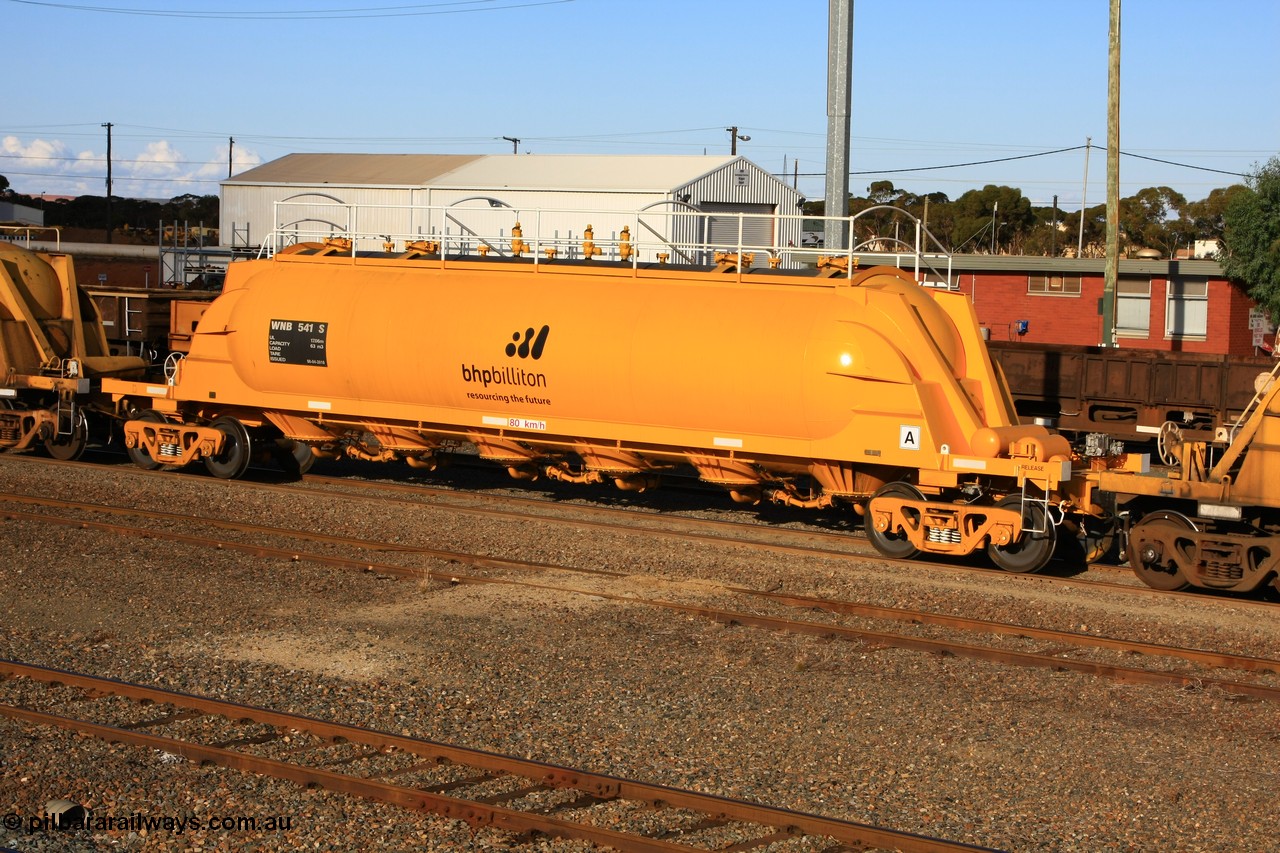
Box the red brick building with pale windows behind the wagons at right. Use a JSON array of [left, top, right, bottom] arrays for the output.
[[936, 255, 1275, 356]]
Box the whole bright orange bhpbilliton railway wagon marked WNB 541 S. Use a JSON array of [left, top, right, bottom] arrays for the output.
[[108, 202, 1083, 571]]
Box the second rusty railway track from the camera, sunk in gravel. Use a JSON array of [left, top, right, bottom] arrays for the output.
[[0, 481, 1280, 701]]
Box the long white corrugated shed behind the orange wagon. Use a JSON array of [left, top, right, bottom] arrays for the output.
[[221, 154, 804, 263]]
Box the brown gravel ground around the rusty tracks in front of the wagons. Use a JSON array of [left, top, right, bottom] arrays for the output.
[[0, 456, 1280, 852]]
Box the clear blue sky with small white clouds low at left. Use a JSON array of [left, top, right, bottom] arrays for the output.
[[0, 0, 1280, 210]]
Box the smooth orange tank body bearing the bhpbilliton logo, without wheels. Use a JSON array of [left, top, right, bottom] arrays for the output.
[[162, 254, 1016, 479]]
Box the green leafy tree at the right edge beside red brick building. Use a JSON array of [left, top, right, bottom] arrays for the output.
[[1219, 158, 1280, 321]]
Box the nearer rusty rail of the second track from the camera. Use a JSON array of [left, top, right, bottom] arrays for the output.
[[6, 510, 1280, 702]]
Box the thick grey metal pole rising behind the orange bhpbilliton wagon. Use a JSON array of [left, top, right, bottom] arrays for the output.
[[823, 0, 854, 250]]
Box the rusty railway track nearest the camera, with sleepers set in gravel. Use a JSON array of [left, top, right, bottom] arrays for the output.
[[0, 661, 989, 853]]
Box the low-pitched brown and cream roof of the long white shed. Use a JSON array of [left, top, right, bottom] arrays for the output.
[[223, 154, 742, 192]]
